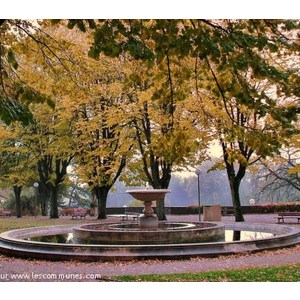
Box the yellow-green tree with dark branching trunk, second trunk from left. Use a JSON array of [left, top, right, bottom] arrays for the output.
[[18, 103, 75, 218]]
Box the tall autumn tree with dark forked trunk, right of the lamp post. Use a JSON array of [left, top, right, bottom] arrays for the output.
[[197, 23, 299, 221]]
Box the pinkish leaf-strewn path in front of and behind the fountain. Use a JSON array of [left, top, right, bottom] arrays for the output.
[[0, 215, 300, 281]]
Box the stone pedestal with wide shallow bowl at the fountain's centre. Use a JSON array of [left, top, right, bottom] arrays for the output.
[[125, 189, 170, 229]]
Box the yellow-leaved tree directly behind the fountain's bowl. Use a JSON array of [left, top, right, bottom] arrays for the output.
[[122, 60, 208, 220]]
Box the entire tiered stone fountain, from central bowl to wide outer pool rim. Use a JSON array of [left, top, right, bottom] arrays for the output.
[[0, 190, 300, 261]]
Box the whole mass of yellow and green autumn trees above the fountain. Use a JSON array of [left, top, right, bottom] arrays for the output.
[[0, 20, 300, 221]]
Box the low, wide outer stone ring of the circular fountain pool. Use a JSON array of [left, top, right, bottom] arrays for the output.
[[0, 222, 300, 261]]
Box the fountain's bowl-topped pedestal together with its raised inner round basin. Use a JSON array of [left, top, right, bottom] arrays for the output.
[[73, 189, 225, 245]]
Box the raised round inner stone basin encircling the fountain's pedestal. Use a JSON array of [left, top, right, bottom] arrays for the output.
[[73, 222, 225, 245]]
